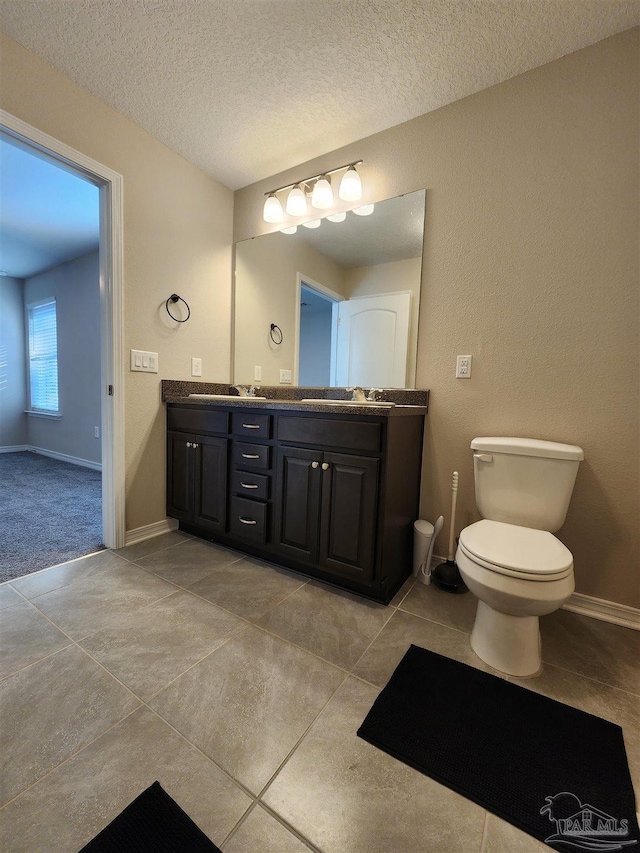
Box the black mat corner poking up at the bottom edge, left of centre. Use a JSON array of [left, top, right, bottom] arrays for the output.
[[80, 782, 221, 853]]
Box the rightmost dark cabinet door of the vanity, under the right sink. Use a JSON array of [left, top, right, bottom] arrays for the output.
[[318, 453, 380, 581]]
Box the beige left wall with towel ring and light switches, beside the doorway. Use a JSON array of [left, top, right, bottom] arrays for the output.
[[0, 34, 233, 530]]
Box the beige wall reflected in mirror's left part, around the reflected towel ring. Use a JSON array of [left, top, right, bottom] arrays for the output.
[[233, 234, 344, 385]]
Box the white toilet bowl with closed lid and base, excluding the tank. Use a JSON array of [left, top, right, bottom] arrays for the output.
[[456, 520, 574, 677]]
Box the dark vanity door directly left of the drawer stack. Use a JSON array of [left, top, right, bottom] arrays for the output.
[[193, 436, 228, 533]]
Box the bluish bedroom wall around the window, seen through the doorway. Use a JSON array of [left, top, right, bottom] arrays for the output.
[[24, 251, 101, 463]]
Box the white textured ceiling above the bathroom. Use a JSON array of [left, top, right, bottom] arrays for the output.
[[0, 0, 640, 189]]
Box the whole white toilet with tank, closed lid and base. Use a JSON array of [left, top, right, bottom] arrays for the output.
[[456, 438, 584, 677]]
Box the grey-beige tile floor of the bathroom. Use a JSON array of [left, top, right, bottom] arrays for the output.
[[0, 533, 640, 853]]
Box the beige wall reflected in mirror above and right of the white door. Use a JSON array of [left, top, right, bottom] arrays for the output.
[[344, 258, 422, 388]]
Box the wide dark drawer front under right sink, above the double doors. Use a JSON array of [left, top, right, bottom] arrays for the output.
[[278, 417, 382, 453]]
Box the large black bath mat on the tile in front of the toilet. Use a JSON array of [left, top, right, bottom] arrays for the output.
[[358, 646, 640, 853]]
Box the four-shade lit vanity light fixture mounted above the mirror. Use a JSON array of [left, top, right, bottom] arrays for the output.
[[262, 160, 362, 223]]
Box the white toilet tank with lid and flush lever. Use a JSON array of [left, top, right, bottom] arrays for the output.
[[471, 438, 584, 533]]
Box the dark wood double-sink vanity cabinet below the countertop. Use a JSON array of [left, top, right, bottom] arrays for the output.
[[167, 403, 424, 602]]
